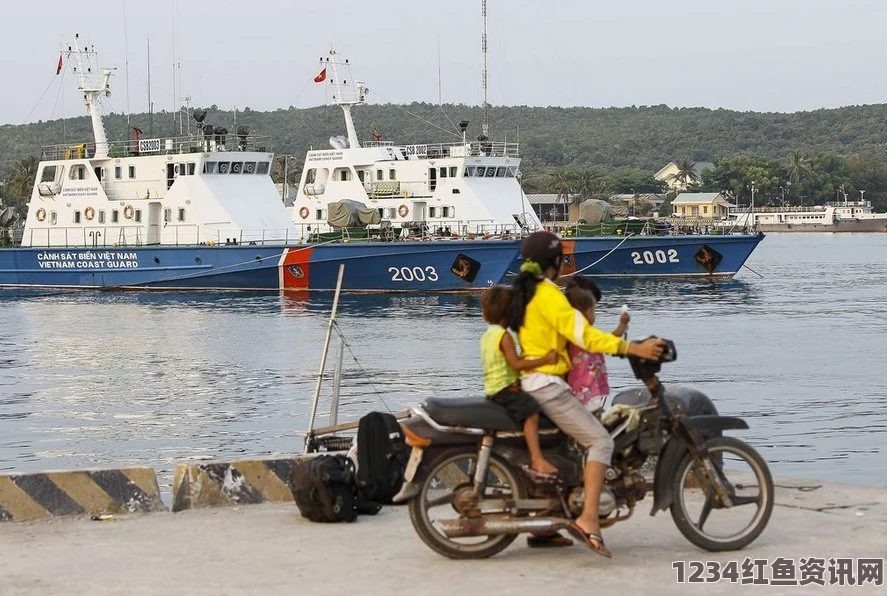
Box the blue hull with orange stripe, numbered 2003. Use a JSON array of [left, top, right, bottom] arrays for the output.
[[0, 241, 519, 292]]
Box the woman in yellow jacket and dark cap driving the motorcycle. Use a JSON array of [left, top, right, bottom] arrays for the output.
[[510, 232, 663, 557]]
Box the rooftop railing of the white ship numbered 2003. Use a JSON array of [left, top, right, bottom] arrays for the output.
[[40, 133, 271, 160]]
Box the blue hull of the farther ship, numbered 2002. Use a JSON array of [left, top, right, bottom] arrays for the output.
[[511, 234, 764, 279]]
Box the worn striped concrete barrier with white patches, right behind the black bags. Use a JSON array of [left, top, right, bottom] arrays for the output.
[[172, 455, 310, 511]]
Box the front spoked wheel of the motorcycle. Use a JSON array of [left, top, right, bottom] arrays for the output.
[[671, 437, 774, 551]]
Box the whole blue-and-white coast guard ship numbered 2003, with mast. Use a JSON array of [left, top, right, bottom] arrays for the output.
[[0, 38, 519, 291]]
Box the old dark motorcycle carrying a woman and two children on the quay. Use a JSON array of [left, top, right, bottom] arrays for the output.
[[394, 340, 774, 559]]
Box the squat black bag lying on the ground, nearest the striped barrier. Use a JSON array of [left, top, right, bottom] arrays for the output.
[[290, 455, 381, 522]]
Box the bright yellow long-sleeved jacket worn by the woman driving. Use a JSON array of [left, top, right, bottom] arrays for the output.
[[518, 279, 628, 376]]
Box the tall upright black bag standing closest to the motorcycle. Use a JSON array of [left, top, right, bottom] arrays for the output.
[[357, 412, 409, 503]]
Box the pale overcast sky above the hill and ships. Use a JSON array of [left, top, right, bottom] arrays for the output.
[[0, 0, 887, 123]]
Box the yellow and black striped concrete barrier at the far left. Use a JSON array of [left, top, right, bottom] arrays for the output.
[[0, 468, 167, 521]]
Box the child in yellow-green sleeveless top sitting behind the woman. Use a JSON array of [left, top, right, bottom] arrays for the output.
[[480, 286, 557, 475]]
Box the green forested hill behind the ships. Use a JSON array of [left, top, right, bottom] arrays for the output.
[[0, 103, 887, 196]]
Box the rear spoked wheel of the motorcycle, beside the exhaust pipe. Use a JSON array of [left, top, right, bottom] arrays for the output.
[[410, 449, 520, 559]]
